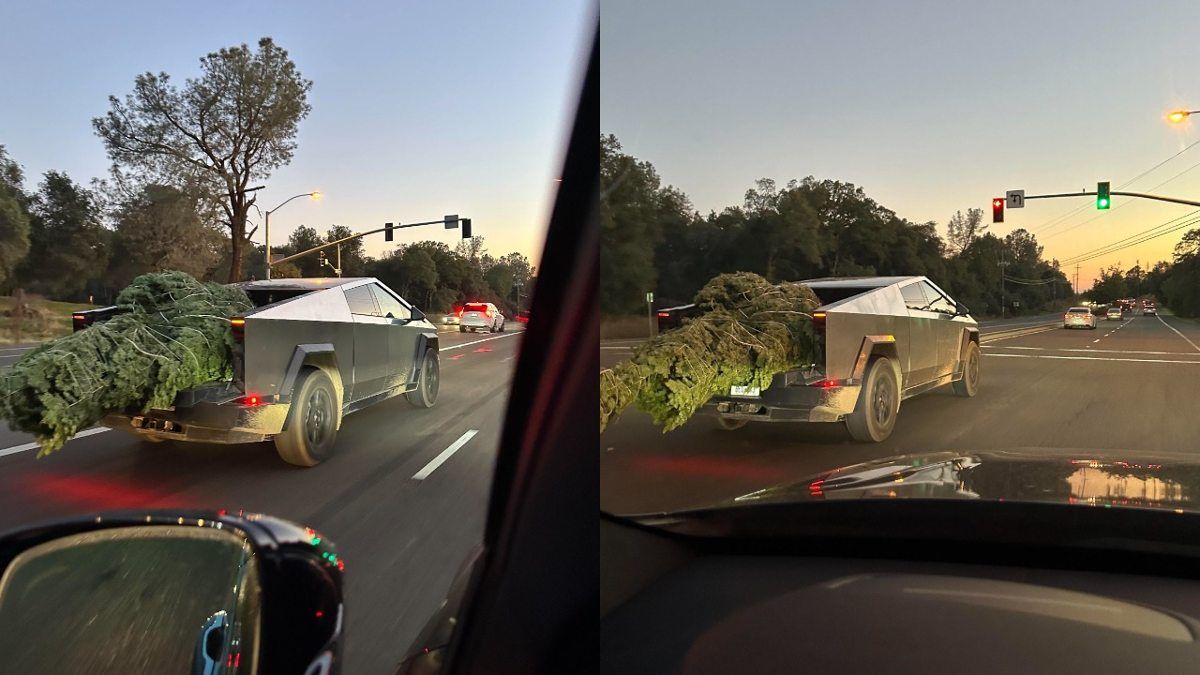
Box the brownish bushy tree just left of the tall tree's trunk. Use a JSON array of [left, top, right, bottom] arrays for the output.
[[106, 185, 226, 288]]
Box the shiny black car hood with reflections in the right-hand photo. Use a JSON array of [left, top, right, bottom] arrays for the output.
[[725, 448, 1200, 513]]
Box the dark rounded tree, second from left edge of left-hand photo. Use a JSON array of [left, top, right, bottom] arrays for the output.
[[18, 171, 109, 300]]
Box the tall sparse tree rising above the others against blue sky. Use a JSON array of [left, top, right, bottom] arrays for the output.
[[92, 37, 312, 281]]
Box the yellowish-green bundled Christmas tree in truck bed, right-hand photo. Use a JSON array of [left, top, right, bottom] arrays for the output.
[[600, 273, 820, 431]]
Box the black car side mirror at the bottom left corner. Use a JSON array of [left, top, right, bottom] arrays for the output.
[[0, 513, 344, 674]]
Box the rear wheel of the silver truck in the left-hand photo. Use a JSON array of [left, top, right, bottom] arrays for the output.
[[275, 368, 337, 466]]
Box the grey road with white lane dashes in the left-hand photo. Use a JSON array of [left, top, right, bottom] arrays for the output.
[[0, 322, 522, 674]]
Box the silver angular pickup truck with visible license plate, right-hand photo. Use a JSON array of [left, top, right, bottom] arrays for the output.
[[706, 276, 982, 442]]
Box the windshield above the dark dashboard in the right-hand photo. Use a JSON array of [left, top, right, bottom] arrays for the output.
[[599, 0, 1200, 522]]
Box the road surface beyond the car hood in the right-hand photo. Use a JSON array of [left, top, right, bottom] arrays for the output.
[[600, 313, 1200, 514]]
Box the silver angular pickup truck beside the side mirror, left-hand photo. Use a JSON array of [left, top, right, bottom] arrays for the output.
[[78, 277, 440, 466]]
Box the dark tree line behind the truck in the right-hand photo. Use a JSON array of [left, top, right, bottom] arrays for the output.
[[600, 135, 1072, 316]]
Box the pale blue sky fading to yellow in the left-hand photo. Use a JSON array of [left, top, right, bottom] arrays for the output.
[[0, 0, 595, 264]]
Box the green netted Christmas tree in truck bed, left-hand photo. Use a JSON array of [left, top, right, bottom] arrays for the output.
[[0, 271, 252, 455]]
